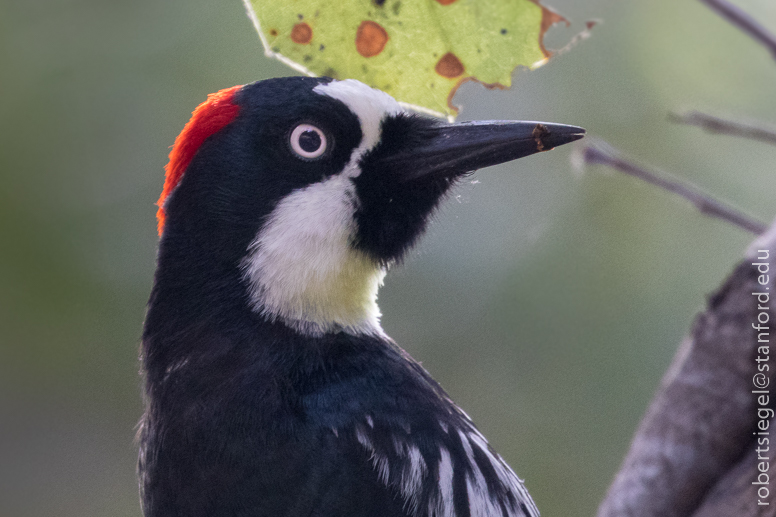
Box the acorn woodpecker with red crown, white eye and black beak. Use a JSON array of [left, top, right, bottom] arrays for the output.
[[139, 77, 584, 517]]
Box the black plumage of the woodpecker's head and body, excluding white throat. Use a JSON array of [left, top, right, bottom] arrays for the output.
[[139, 78, 581, 517]]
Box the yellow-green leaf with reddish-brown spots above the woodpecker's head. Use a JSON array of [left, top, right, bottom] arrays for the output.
[[244, 0, 565, 117]]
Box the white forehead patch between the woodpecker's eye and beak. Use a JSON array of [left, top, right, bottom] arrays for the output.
[[313, 79, 404, 158]]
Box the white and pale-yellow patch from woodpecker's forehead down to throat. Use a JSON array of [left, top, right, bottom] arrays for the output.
[[242, 80, 402, 336]]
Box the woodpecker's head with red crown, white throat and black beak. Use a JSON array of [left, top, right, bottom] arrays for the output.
[[157, 77, 584, 335]]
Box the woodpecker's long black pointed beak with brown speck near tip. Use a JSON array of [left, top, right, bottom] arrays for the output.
[[380, 120, 585, 181]]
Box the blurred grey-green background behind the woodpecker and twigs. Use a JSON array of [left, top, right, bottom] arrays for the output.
[[0, 0, 776, 517]]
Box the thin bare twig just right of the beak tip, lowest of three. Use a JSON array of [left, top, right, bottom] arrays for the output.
[[582, 141, 768, 235]]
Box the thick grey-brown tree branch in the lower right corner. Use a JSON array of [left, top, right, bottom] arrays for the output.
[[598, 225, 776, 517]]
